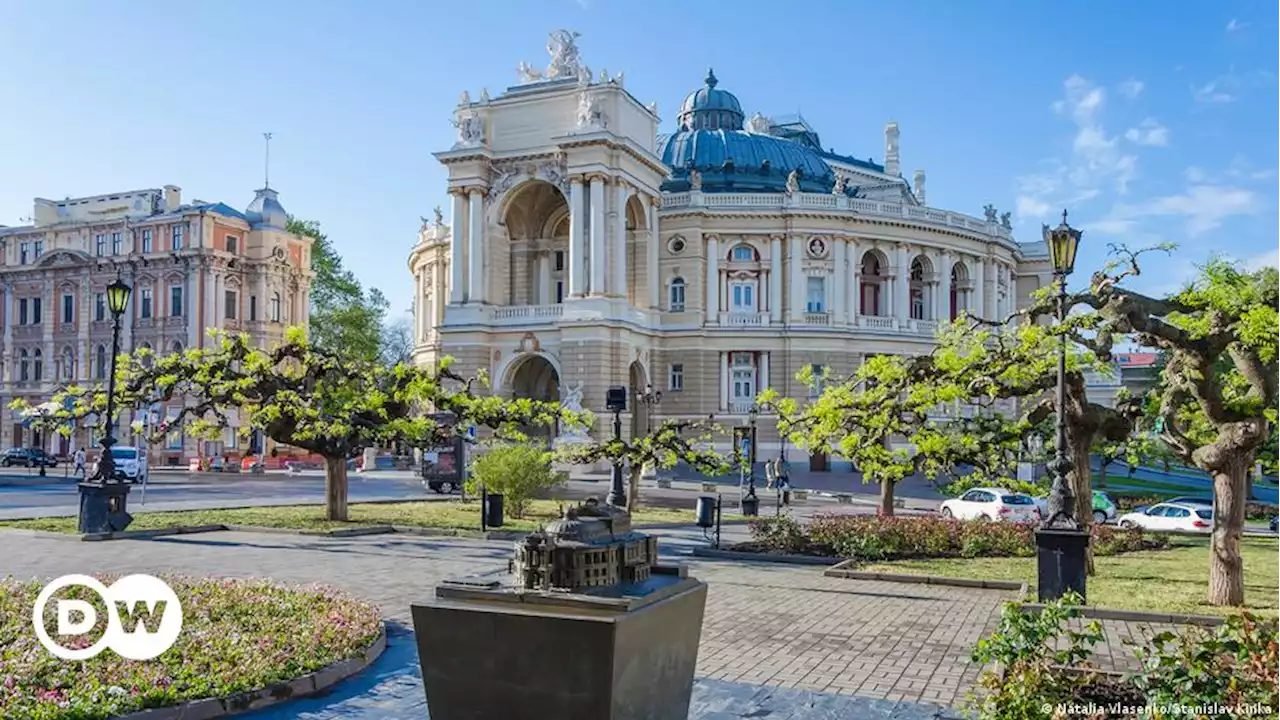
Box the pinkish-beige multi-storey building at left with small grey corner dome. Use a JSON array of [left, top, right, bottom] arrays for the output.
[[0, 186, 311, 464]]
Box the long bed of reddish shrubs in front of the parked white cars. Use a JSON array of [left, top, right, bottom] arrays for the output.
[[733, 515, 1169, 561]]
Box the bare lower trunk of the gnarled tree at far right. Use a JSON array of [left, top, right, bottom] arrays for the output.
[[1208, 459, 1249, 606]]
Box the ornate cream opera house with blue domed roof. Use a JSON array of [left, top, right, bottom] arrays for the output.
[[408, 31, 1052, 450]]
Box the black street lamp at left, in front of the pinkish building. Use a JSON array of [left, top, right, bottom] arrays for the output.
[[79, 277, 133, 533]]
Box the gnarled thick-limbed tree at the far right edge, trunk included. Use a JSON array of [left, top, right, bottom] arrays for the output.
[[1080, 254, 1280, 605]]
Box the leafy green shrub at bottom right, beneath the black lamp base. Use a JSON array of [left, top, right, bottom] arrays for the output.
[[973, 594, 1103, 720]]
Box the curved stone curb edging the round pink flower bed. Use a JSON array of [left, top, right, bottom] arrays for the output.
[[114, 621, 387, 720]]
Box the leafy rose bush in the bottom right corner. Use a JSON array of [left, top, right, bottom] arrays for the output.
[[1134, 614, 1280, 717]]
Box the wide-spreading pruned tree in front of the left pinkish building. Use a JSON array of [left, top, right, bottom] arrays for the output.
[[13, 328, 581, 520]]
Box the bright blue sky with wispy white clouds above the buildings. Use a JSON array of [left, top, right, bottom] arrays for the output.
[[0, 0, 1280, 310]]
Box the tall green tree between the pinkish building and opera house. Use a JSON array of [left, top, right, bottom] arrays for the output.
[[285, 218, 388, 361]]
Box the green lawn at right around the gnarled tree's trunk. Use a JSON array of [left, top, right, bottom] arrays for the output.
[[858, 537, 1280, 616]]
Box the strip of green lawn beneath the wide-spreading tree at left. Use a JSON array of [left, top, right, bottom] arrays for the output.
[[0, 500, 694, 533]]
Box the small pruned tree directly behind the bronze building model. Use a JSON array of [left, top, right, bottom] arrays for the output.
[[556, 420, 731, 512]]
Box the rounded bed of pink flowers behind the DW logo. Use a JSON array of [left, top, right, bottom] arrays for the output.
[[0, 577, 381, 720]]
